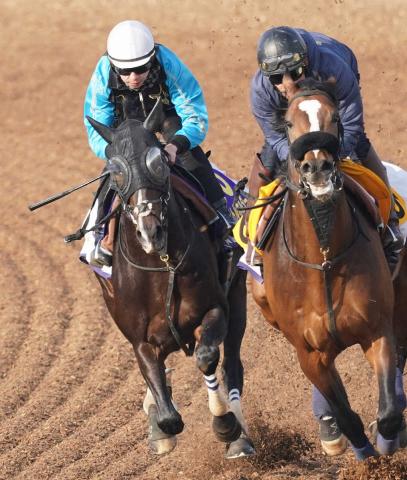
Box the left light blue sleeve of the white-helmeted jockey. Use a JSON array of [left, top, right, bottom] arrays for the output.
[[83, 56, 114, 160]]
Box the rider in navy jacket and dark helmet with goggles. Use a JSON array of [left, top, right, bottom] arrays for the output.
[[249, 26, 404, 270]]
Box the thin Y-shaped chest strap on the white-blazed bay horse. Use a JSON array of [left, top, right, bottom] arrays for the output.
[[283, 190, 361, 350]]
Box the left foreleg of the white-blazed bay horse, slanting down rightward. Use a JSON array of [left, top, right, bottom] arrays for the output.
[[297, 347, 375, 460]]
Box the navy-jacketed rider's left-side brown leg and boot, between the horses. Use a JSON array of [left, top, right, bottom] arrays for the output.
[[244, 153, 273, 266]]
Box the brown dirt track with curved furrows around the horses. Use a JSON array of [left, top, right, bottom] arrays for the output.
[[0, 0, 407, 480]]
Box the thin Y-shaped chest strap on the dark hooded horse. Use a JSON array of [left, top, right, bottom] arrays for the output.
[[117, 189, 195, 357]]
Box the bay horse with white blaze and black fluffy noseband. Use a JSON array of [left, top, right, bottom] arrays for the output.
[[253, 74, 402, 460]]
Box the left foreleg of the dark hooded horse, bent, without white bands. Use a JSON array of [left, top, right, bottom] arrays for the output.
[[133, 342, 184, 435]]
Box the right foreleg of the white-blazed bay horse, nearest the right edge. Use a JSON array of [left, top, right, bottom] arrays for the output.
[[364, 337, 403, 455]]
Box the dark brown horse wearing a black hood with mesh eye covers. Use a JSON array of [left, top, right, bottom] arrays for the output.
[[89, 107, 254, 458]]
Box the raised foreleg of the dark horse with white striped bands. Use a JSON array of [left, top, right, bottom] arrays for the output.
[[195, 307, 241, 442]]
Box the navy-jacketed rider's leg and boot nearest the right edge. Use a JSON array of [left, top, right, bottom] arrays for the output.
[[363, 145, 404, 273]]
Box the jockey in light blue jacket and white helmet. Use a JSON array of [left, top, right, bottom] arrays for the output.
[[84, 20, 233, 266]]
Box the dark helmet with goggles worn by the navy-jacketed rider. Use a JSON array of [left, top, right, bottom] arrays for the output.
[[257, 27, 307, 76]]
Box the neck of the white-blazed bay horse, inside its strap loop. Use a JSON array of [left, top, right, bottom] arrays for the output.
[[284, 191, 355, 262]]
